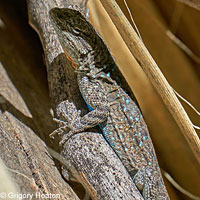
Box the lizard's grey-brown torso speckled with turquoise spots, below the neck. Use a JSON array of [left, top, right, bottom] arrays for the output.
[[78, 71, 169, 200]]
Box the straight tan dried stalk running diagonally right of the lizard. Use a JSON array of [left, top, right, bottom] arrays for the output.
[[101, 0, 200, 163]]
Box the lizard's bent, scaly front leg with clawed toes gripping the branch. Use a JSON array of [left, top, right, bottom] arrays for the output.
[[52, 73, 109, 145]]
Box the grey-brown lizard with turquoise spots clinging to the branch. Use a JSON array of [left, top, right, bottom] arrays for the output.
[[49, 8, 169, 200]]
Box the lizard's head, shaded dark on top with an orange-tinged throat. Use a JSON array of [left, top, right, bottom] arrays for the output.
[[49, 8, 95, 66]]
